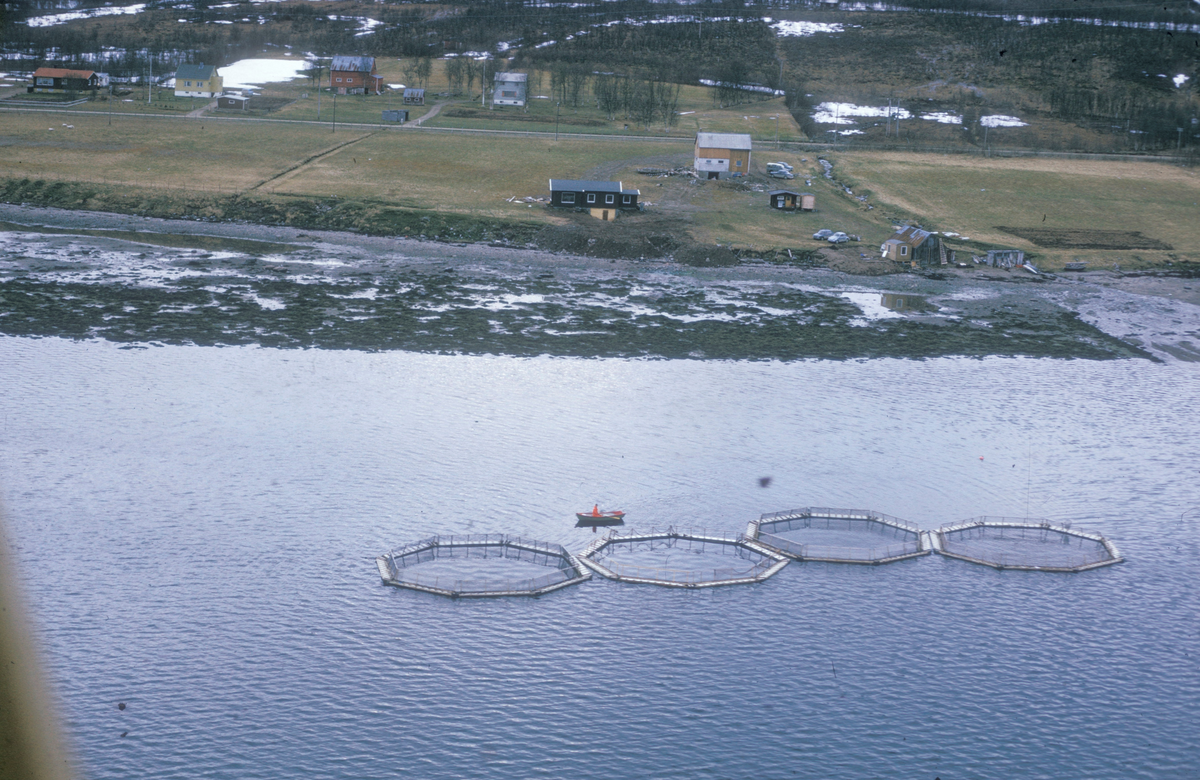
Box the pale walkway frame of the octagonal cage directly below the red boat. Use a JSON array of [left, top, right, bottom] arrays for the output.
[[578, 526, 788, 588]]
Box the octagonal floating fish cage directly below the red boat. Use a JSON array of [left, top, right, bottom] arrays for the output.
[[580, 527, 787, 588]]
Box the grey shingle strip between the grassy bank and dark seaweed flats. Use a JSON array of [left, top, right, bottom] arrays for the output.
[[0, 204, 1200, 362]]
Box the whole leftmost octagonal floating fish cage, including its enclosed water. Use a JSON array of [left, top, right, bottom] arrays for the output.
[[377, 534, 589, 596]]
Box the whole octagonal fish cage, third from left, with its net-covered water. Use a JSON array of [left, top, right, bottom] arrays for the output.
[[746, 506, 930, 564]]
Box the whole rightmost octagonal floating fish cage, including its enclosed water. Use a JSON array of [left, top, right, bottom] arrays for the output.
[[934, 517, 1123, 571]]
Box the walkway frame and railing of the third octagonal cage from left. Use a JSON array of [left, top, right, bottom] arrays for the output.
[[745, 506, 931, 565]]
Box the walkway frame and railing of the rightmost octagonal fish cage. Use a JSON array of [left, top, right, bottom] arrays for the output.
[[931, 516, 1124, 571]]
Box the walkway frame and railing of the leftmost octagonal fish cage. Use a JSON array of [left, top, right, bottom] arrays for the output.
[[376, 534, 592, 598]]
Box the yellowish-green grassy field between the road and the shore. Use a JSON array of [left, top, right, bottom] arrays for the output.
[[0, 106, 1200, 270]]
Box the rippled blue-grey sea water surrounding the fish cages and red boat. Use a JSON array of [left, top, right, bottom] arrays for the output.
[[0, 337, 1200, 780]]
